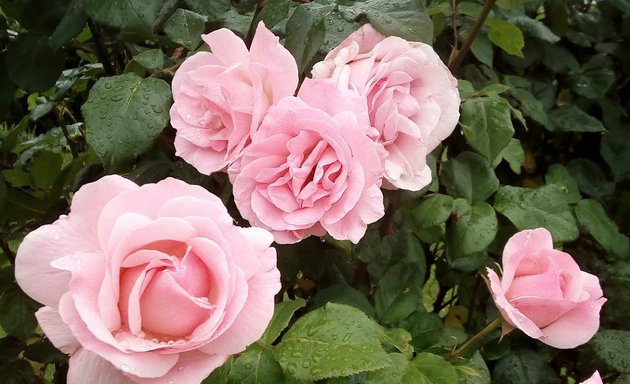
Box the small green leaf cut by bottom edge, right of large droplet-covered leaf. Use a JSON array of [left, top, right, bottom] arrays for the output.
[[400, 352, 459, 384]]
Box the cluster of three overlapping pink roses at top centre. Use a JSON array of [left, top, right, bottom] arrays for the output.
[[171, 22, 460, 244]]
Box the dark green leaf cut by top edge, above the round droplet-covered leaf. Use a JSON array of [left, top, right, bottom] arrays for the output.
[[84, 0, 164, 37]]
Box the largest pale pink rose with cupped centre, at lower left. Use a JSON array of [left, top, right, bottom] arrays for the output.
[[15, 176, 280, 384]]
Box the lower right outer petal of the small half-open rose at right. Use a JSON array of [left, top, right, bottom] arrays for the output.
[[540, 298, 606, 349]]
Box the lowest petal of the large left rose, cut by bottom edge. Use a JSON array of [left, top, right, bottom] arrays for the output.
[[67, 349, 133, 384]]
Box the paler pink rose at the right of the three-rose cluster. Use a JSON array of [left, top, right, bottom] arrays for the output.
[[312, 24, 460, 191]]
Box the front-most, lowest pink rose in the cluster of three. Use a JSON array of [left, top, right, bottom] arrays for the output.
[[228, 79, 384, 244]]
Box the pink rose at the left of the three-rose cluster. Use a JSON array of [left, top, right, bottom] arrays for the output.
[[170, 22, 298, 174]]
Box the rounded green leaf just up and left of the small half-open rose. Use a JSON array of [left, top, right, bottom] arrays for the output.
[[446, 199, 498, 258]]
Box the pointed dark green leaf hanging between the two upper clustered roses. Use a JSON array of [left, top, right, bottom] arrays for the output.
[[284, 3, 333, 73]]
